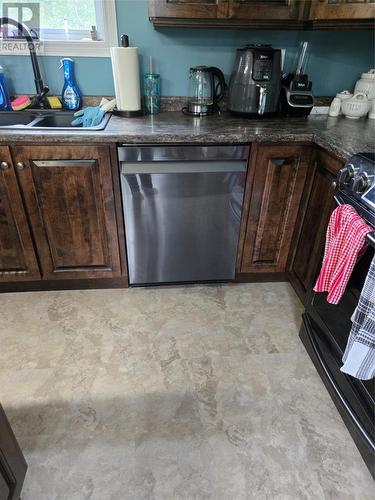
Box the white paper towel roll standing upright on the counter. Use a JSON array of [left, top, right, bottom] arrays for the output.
[[111, 47, 141, 111]]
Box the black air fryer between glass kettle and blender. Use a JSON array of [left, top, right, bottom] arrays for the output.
[[228, 45, 281, 116]]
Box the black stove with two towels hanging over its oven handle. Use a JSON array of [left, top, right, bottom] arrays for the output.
[[300, 153, 375, 477]]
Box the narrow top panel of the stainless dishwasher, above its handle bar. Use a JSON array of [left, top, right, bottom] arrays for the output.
[[117, 144, 250, 162]]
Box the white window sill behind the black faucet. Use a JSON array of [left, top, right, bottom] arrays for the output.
[[0, 40, 110, 57]]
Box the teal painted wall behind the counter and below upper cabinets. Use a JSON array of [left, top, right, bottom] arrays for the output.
[[0, 0, 375, 95]]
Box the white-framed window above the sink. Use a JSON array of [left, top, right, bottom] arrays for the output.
[[0, 0, 117, 56]]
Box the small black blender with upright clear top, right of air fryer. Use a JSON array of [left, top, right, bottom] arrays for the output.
[[280, 42, 314, 117]]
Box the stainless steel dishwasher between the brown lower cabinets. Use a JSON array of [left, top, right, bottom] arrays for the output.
[[118, 145, 249, 285]]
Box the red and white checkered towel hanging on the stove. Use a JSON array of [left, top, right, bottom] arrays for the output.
[[314, 205, 372, 304]]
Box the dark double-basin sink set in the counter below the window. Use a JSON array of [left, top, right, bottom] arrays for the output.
[[0, 109, 111, 130]]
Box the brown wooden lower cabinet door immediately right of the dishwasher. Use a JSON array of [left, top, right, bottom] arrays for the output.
[[239, 145, 311, 273]]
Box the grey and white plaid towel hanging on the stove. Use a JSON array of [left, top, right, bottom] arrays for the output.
[[341, 256, 375, 380]]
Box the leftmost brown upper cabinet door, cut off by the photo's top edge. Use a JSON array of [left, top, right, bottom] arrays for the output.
[[149, 0, 228, 19]]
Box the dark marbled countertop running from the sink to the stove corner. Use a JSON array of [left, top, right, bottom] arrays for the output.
[[0, 111, 375, 160]]
